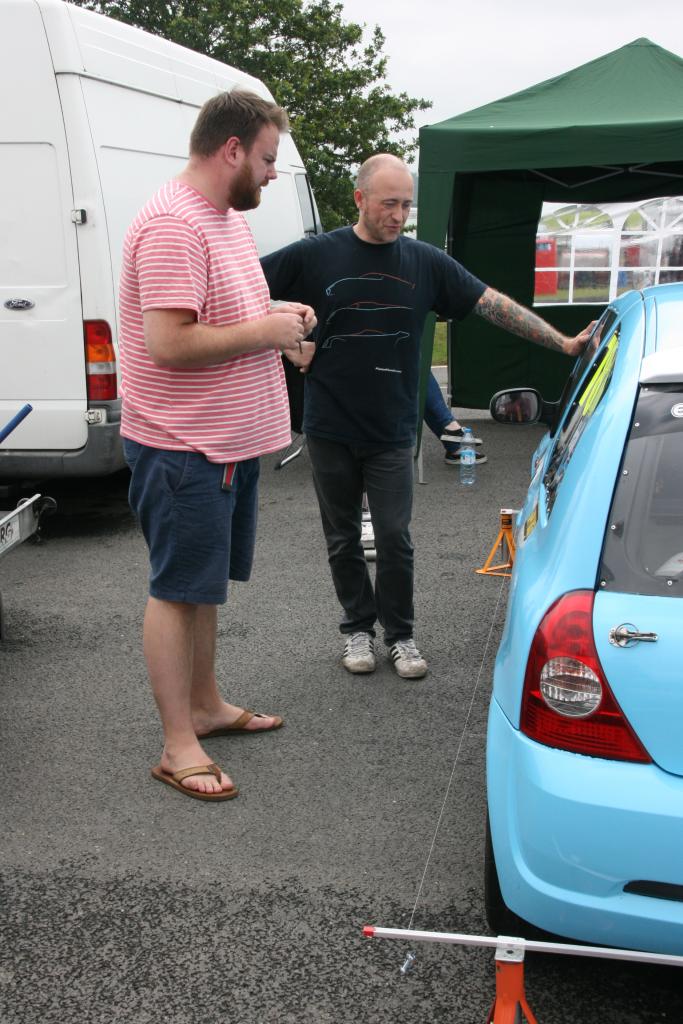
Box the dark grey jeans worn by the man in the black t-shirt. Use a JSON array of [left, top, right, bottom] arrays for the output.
[[306, 436, 415, 646]]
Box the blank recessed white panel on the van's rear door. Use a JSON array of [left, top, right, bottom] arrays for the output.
[[0, 142, 68, 289]]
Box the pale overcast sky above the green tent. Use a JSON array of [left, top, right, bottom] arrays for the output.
[[341, 0, 683, 127]]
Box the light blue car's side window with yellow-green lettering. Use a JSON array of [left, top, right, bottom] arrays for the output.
[[543, 321, 618, 515]]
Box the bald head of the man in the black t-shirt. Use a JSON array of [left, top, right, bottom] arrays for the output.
[[353, 153, 413, 245]]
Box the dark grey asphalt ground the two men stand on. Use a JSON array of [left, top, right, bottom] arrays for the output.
[[0, 382, 683, 1024]]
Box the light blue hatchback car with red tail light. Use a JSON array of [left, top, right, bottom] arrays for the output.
[[485, 285, 683, 954]]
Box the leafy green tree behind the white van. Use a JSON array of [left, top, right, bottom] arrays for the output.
[[72, 0, 431, 230]]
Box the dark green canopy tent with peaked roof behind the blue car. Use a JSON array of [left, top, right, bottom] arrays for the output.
[[418, 39, 683, 409]]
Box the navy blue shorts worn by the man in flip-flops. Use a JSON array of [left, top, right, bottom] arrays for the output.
[[123, 438, 259, 604]]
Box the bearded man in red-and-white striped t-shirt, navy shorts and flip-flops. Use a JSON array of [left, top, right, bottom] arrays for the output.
[[120, 90, 315, 801]]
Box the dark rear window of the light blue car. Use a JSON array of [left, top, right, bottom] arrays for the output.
[[598, 383, 683, 597]]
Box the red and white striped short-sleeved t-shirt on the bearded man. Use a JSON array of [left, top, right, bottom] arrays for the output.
[[120, 180, 291, 463]]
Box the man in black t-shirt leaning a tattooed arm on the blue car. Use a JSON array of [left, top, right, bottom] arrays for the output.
[[261, 154, 588, 679]]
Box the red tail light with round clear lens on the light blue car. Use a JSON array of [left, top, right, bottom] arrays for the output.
[[520, 590, 651, 763]]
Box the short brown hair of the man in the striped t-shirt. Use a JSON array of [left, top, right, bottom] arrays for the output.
[[189, 89, 289, 157]]
